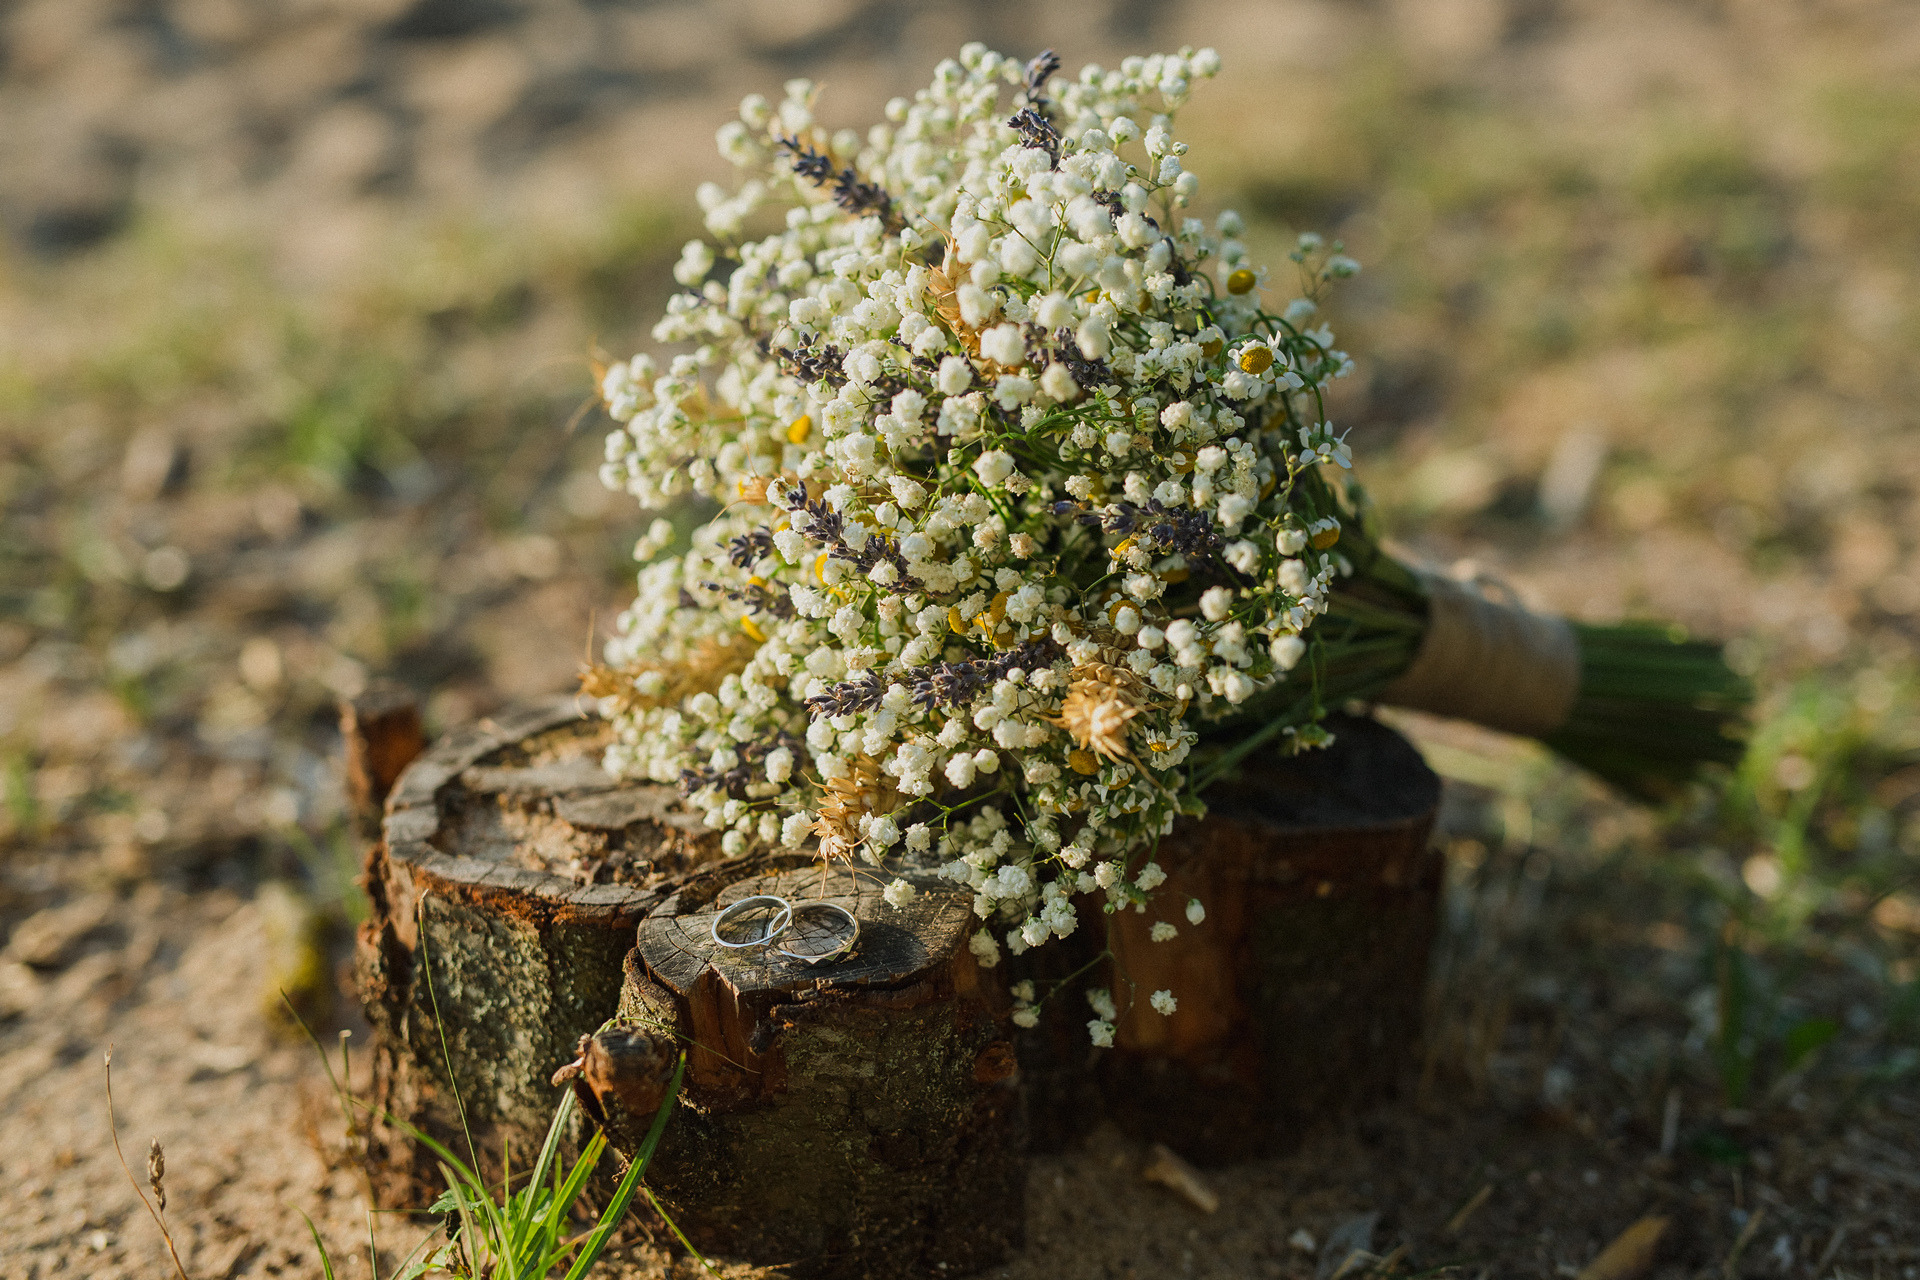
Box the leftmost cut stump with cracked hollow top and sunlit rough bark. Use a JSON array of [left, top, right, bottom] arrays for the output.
[[349, 699, 718, 1203]]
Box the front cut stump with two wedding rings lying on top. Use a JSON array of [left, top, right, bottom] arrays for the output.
[[582, 864, 1025, 1280]]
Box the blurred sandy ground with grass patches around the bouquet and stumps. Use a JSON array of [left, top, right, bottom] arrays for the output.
[[0, 0, 1920, 1276]]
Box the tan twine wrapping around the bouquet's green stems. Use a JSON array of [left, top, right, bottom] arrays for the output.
[[1380, 574, 1580, 737]]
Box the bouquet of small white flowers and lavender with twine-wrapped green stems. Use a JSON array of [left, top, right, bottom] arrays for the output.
[[584, 44, 1745, 963]]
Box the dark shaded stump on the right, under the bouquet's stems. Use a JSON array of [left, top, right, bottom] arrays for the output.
[[1021, 718, 1444, 1165]]
